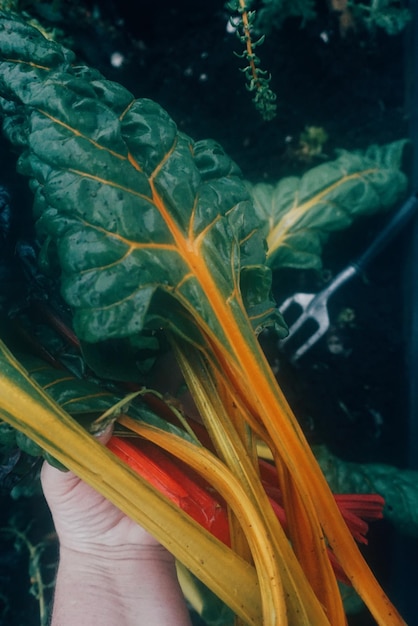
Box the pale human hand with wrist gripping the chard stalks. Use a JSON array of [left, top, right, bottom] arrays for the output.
[[41, 432, 190, 626]]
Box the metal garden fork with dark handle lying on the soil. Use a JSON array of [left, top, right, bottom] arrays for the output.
[[278, 193, 418, 363]]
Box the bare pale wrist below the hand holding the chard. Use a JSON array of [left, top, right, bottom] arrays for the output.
[[52, 545, 190, 626]]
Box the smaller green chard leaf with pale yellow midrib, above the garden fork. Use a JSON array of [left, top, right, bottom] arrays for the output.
[[248, 141, 407, 269]]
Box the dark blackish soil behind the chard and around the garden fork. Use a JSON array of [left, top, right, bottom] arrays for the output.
[[0, 0, 416, 626]]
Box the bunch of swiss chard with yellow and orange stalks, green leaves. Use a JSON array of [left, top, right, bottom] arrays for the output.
[[0, 14, 406, 626]]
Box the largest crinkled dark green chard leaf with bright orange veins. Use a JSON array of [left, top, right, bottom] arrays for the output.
[[0, 13, 284, 342]]
